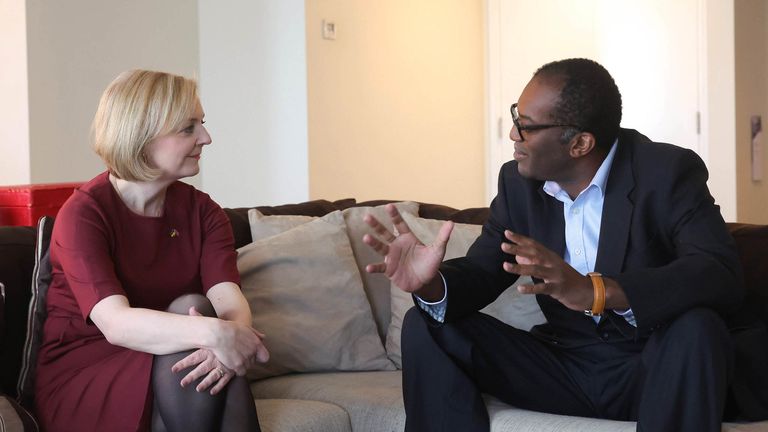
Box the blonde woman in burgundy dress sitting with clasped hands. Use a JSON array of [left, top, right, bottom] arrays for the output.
[[35, 70, 269, 432]]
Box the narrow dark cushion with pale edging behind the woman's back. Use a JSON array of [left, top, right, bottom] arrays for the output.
[[17, 216, 54, 410]]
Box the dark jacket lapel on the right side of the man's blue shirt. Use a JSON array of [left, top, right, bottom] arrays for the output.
[[595, 129, 635, 274]]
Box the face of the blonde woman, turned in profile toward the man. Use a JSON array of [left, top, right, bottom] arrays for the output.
[[146, 103, 211, 180]]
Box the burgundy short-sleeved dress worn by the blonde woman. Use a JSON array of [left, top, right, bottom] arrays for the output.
[[35, 173, 240, 432]]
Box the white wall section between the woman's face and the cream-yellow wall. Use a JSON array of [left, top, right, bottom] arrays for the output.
[[200, 0, 309, 207]]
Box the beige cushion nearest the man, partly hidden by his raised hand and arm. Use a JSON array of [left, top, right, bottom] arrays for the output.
[[385, 215, 546, 368]]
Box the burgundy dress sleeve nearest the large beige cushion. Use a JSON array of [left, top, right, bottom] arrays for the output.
[[200, 195, 240, 293]]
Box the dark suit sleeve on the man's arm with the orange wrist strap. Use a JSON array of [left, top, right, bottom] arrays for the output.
[[603, 150, 744, 331]]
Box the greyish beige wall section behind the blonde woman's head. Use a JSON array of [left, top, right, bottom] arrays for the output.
[[22, 0, 198, 184]]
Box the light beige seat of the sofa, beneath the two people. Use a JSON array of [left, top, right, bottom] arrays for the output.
[[251, 371, 768, 432]]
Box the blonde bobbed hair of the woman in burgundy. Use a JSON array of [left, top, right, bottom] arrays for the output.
[[91, 70, 199, 181]]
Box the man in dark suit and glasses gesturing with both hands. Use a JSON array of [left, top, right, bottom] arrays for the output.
[[364, 59, 743, 432]]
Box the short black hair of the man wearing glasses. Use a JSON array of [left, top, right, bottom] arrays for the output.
[[533, 58, 621, 151]]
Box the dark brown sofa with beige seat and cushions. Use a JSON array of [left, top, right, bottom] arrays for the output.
[[0, 199, 768, 432]]
